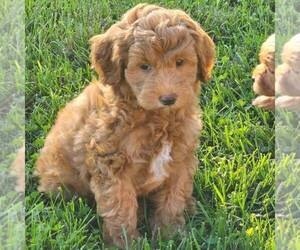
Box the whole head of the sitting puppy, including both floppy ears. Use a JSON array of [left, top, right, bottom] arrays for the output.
[[91, 4, 215, 110]]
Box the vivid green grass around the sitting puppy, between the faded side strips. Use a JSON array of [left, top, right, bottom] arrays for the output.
[[26, 0, 275, 250]]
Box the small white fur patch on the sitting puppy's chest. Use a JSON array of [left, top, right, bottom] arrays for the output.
[[150, 143, 172, 180]]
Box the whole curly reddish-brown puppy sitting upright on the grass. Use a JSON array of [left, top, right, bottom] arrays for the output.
[[36, 4, 215, 247]]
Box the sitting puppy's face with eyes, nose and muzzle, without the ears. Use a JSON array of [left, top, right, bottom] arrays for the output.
[[125, 23, 198, 109]]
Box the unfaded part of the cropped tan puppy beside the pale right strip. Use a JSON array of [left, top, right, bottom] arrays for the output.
[[252, 34, 275, 110]]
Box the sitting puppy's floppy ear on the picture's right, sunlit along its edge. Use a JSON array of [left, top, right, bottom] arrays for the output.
[[181, 13, 215, 82]]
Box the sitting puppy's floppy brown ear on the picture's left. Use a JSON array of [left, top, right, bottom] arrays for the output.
[[90, 27, 129, 85]]
